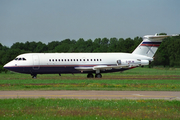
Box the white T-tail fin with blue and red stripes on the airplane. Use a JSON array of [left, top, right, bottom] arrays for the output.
[[132, 34, 178, 57]]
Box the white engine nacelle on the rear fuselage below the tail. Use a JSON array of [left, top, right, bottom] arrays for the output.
[[117, 59, 149, 67]]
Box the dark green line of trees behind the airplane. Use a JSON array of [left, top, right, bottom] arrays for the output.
[[0, 33, 180, 72]]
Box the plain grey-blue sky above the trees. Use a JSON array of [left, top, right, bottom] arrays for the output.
[[0, 0, 180, 47]]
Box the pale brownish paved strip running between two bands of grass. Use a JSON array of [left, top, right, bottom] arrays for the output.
[[0, 90, 180, 100]]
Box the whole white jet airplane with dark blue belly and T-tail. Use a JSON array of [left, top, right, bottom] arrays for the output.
[[4, 34, 179, 78]]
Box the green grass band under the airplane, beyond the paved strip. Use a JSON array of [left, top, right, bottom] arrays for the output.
[[0, 68, 180, 91]]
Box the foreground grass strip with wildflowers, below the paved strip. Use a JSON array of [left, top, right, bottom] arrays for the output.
[[0, 98, 180, 120]]
